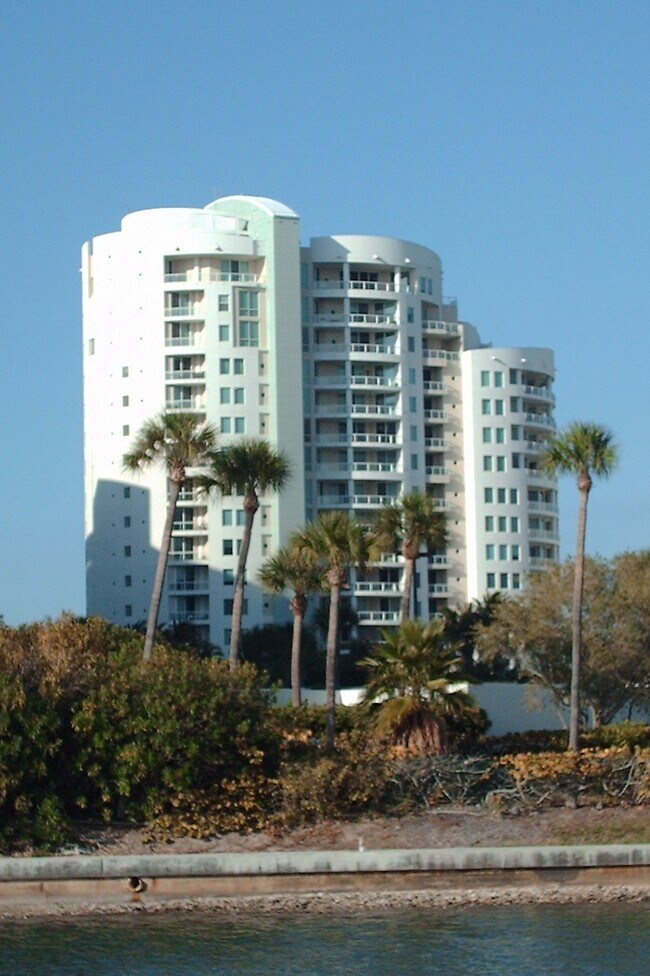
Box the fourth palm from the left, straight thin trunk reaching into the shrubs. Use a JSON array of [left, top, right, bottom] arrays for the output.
[[291, 511, 373, 750]]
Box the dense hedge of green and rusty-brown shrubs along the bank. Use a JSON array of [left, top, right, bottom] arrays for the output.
[[0, 616, 650, 851]]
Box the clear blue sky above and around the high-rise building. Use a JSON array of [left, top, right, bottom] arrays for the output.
[[0, 0, 650, 624]]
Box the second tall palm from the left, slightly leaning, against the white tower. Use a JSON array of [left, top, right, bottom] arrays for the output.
[[198, 437, 289, 670]]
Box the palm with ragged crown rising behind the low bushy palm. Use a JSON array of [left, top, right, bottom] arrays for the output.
[[374, 491, 447, 622]]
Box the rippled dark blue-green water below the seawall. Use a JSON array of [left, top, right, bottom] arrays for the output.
[[0, 904, 650, 976]]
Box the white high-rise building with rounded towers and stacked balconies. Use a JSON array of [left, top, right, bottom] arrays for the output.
[[82, 196, 558, 647]]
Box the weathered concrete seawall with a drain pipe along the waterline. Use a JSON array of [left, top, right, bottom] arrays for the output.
[[0, 844, 650, 916]]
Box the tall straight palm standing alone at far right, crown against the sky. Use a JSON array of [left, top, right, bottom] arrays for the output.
[[541, 422, 618, 751]]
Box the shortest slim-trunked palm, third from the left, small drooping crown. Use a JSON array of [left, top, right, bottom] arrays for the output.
[[257, 546, 323, 707]]
